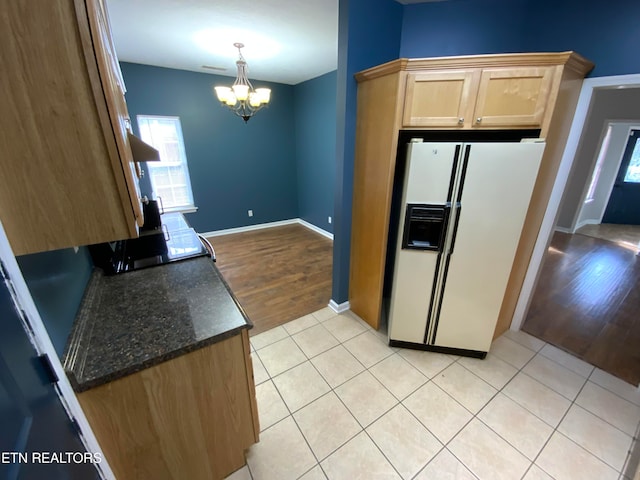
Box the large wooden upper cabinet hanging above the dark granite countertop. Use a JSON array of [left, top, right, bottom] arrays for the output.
[[0, 0, 143, 255]]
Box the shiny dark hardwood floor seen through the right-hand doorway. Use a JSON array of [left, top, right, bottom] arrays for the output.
[[522, 232, 640, 385]]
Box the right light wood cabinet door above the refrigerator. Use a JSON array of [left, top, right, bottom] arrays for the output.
[[473, 67, 555, 128]]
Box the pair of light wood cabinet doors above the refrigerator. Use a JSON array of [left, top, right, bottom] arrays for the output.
[[402, 67, 556, 129]]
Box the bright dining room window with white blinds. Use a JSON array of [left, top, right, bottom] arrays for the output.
[[137, 115, 195, 211]]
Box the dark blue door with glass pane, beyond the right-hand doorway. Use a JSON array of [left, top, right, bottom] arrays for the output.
[[602, 130, 640, 225]]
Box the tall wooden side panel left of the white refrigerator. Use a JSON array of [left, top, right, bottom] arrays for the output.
[[349, 73, 405, 329]]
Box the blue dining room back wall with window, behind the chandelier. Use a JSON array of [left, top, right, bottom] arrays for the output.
[[121, 63, 298, 232]]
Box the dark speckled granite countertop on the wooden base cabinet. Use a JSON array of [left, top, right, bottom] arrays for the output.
[[63, 257, 252, 392]]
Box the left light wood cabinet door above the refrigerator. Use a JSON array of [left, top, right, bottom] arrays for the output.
[[402, 70, 474, 127]]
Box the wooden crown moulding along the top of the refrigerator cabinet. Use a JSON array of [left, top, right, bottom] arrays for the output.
[[355, 51, 594, 82]]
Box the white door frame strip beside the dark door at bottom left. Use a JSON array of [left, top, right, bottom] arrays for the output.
[[0, 222, 115, 480]]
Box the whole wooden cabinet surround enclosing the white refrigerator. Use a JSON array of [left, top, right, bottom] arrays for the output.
[[349, 52, 593, 334]]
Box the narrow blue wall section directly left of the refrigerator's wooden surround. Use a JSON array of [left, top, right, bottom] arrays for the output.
[[331, 0, 403, 303]]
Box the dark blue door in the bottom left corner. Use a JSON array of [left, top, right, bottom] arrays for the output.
[[0, 263, 100, 480]]
